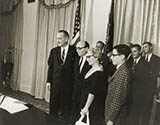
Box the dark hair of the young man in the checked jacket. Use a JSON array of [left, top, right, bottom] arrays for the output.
[[113, 44, 130, 58]]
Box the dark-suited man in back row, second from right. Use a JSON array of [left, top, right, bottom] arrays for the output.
[[128, 44, 152, 125]]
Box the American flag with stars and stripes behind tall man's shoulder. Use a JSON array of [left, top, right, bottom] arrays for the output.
[[72, 0, 81, 45]]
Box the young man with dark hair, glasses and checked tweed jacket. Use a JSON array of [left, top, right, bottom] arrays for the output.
[[105, 44, 130, 125]]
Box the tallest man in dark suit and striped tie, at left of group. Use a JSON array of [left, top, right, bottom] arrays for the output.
[[47, 30, 77, 125]]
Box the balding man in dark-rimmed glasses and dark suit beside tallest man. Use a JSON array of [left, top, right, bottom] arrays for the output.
[[72, 41, 91, 122]]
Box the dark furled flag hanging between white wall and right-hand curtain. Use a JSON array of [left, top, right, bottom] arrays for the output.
[[105, 0, 114, 53]]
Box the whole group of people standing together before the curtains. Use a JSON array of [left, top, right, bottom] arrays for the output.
[[47, 30, 160, 125]]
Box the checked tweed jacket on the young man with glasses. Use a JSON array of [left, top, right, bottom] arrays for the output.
[[105, 63, 130, 125]]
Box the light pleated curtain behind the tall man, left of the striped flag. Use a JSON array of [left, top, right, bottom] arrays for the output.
[[32, 0, 77, 100]]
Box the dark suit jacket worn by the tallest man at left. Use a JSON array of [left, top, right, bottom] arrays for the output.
[[47, 46, 77, 96]]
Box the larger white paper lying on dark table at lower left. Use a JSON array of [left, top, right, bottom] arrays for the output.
[[0, 96, 28, 114]]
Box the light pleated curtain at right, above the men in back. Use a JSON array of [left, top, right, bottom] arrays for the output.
[[114, 0, 160, 56]]
